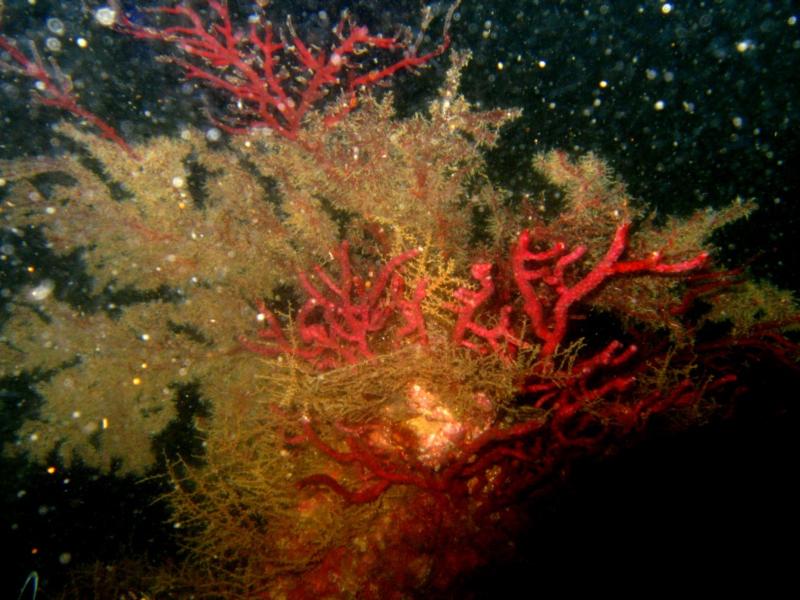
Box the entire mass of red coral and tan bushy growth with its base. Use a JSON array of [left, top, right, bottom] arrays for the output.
[[0, 1, 800, 598]]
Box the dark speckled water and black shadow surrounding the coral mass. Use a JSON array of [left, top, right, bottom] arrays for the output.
[[0, 0, 800, 597]]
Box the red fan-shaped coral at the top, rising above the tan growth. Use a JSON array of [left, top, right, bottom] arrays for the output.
[[117, 0, 450, 140]]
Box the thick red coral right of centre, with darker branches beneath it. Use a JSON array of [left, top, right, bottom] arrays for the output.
[[444, 223, 708, 454]]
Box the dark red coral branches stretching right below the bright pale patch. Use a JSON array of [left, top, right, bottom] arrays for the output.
[[286, 360, 736, 514]]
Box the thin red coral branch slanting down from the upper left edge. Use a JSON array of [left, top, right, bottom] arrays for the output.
[[0, 35, 137, 158]]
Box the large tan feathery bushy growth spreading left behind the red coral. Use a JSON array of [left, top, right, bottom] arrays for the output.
[[2, 51, 513, 471]]
